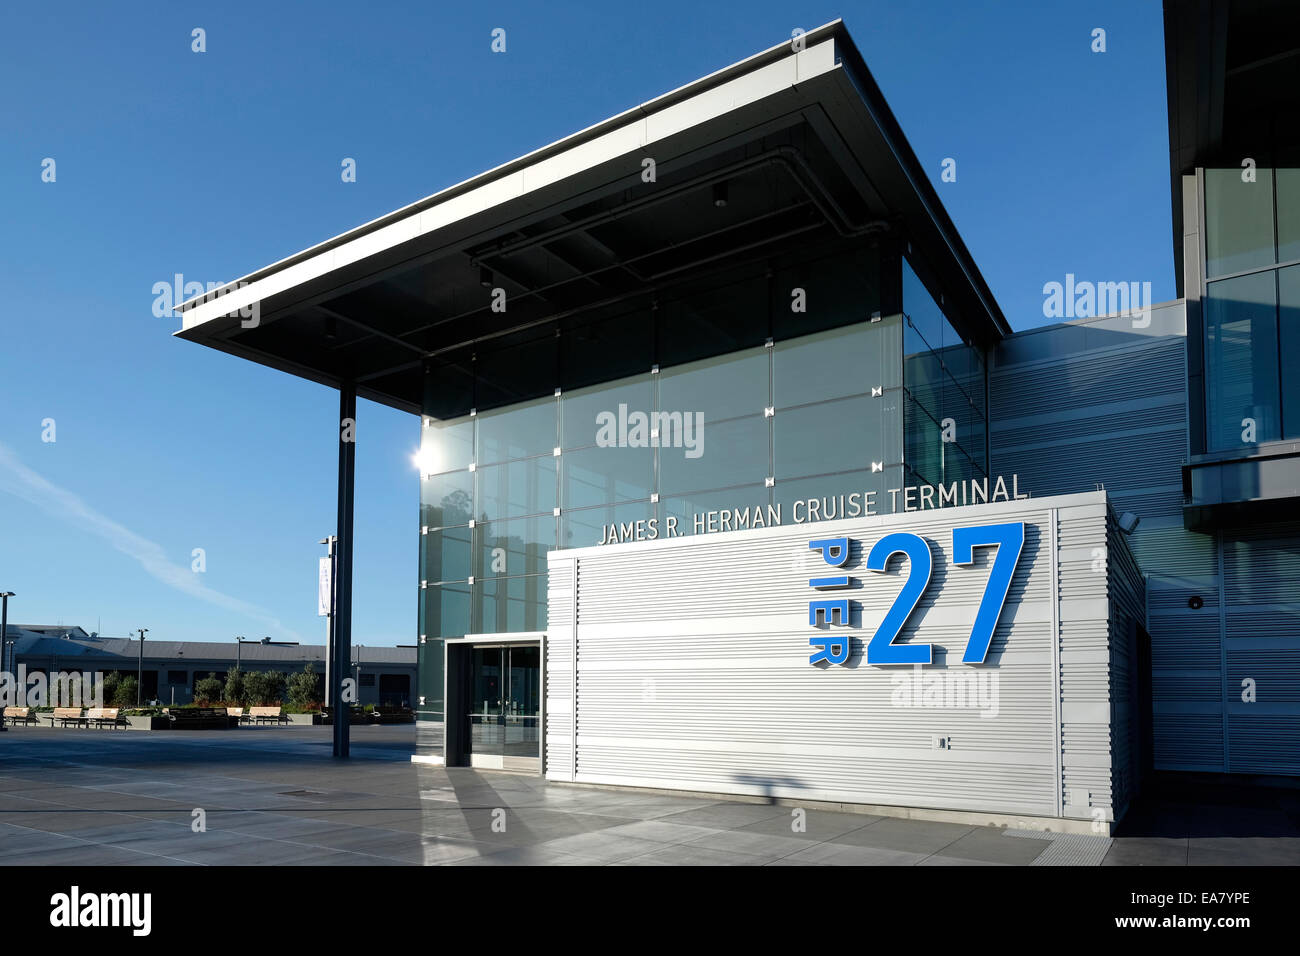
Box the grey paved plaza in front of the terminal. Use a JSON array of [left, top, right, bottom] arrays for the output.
[[0, 726, 1300, 866]]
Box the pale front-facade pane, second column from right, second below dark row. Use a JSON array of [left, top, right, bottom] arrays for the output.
[[659, 414, 770, 494]]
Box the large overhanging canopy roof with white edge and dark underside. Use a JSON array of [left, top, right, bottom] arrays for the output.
[[176, 21, 1010, 414]]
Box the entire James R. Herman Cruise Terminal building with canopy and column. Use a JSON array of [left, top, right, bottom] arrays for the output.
[[178, 13, 1300, 831]]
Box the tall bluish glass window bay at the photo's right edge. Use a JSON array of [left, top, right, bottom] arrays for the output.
[[1205, 168, 1300, 451]]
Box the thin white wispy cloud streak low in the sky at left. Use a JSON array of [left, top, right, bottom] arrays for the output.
[[0, 444, 302, 640]]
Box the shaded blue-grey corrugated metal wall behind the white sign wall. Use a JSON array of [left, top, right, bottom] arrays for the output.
[[989, 303, 1226, 770]]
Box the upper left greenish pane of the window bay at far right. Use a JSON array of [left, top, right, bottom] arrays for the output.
[[1205, 168, 1277, 278]]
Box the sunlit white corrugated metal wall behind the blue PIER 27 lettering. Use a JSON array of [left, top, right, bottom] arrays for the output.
[[546, 496, 1112, 817]]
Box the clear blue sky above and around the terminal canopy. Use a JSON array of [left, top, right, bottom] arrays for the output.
[[0, 0, 1174, 645]]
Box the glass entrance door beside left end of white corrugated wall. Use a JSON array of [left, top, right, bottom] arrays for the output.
[[467, 644, 542, 773]]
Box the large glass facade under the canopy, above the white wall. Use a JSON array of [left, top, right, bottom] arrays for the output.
[[410, 239, 987, 713]]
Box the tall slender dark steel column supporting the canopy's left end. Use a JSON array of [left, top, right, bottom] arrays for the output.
[[330, 381, 356, 757]]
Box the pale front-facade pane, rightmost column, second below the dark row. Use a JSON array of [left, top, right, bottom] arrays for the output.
[[772, 389, 901, 480]]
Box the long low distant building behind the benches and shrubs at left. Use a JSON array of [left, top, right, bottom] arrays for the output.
[[4, 624, 416, 706]]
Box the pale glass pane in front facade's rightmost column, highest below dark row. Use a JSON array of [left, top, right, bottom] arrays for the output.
[[772, 320, 900, 408]]
